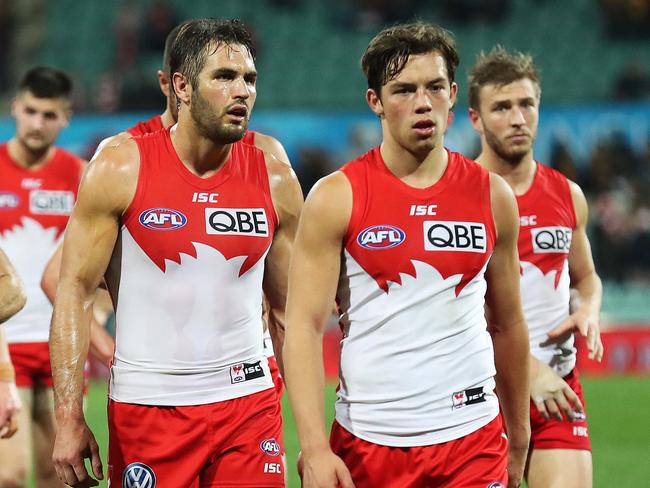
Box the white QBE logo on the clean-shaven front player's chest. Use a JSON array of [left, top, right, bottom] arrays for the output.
[[424, 220, 487, 253]]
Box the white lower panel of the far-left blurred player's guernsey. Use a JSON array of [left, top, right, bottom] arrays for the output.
[[0, 217, 58, 344]]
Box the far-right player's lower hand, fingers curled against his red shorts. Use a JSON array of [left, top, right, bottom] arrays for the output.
[[530, 361, 584, 421]]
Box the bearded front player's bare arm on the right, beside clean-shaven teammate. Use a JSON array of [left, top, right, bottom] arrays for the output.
[[263, 154, 303, 372]]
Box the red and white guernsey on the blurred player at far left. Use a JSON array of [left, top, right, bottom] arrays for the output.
[[0, 144, 83, 343]]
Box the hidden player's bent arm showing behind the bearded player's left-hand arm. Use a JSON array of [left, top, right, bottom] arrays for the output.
[[41, 242, 115, 366]]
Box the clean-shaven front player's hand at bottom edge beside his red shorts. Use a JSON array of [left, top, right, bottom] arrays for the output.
[[298, 447, 354, 488]]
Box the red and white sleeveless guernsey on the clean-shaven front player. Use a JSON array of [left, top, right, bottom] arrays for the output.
[[336, 148, 499, 446]]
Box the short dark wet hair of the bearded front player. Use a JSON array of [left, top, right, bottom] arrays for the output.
[[169, 18, 255, 88]]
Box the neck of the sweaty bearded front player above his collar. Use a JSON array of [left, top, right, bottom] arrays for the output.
[[171, 123, 232, 178]]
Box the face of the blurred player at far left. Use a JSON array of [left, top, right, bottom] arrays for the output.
[[12, 91, 69, 153]]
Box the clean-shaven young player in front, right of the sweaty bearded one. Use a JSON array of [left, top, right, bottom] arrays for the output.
[[284, 23, 529, 488]]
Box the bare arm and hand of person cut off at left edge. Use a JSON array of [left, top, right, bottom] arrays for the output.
[[0, 249, 26, 440]]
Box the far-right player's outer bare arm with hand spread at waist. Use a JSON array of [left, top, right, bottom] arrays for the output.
[[549, 182, 604, 361]]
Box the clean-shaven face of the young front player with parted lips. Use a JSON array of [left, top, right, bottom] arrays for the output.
[[369, 51, 457, 154]]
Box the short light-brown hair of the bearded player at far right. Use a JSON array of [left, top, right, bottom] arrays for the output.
[[469, 45, 541, 110]]
